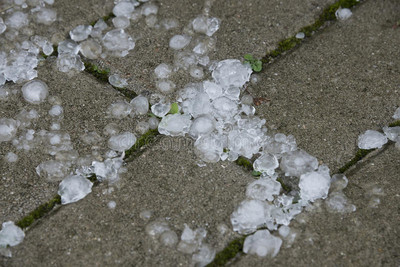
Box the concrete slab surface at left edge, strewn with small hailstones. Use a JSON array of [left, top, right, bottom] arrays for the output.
[[0, 59, 136, 221]]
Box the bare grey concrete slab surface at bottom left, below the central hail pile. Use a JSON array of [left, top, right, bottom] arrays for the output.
[[3, 137, 254, 266]]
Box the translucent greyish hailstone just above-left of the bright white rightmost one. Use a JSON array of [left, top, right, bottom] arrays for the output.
[[280, 150, 318, 177]]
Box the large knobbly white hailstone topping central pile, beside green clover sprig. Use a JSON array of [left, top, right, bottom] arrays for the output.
[[212, 59, 252, 88]]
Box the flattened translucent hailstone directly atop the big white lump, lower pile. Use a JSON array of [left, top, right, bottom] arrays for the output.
[[246, 178, 281, 201]]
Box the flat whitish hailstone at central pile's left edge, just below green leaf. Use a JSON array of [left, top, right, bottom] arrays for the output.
[[158, 114, 192, 136]]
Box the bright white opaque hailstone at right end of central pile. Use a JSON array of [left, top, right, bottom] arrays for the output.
[[299, 165, 331, 202]]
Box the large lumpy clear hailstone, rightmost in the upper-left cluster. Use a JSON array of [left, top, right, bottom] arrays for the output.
[[103, 29, 135, 57]]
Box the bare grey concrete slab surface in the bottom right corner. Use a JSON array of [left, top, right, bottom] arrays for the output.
[[232, 144, 400, 266]]
